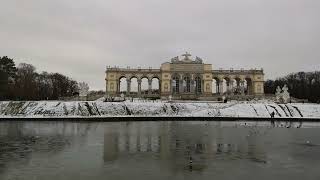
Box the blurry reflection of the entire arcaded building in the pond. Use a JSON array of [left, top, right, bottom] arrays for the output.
[[104, 122, 266, 171]]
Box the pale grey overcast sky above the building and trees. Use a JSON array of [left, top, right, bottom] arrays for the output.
[[0, 0, 320, 89]]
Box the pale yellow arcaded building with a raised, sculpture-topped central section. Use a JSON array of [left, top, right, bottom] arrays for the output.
[[105, 53, 264, 99]]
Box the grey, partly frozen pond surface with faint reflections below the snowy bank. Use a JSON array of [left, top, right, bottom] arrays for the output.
[[0, 121, 320, 180]]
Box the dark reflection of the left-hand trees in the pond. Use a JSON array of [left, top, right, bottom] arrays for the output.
[[0, 122, 91, 177]]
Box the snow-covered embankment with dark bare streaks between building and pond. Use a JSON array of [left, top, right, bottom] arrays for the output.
[[0, 101, 320, 119]]
